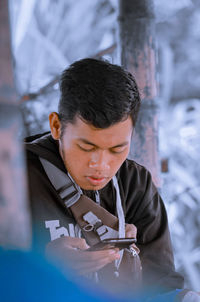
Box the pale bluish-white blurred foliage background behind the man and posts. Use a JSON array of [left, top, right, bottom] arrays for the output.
[[9, 0, 200, 290]]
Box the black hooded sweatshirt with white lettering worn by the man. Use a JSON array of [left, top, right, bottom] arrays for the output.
[[25, 133, 183, 290]]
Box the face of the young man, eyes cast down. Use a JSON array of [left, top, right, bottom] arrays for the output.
[[52, 117, 133, 190]]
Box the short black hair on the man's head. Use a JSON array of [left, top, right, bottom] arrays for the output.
[[58, 58, 141, 129]]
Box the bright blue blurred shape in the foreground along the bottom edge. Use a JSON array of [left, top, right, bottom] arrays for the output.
[[0, 250, 188, 302]]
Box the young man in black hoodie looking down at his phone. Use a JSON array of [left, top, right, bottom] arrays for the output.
[[26, 59, 183, 290]]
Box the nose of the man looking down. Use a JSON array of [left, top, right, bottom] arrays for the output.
[[89, 150, 110, 171]]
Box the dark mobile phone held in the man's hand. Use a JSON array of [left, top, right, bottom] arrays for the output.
[[87, 238, 137, 251]]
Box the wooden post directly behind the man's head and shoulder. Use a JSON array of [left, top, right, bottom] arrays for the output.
[[118, 0, 160, 186]]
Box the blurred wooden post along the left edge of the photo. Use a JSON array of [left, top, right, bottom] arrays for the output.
[[0, 0, 31, 249]]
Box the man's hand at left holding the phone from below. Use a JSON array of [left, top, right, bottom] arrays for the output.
[[46, 237, 120, 275]]
